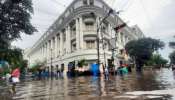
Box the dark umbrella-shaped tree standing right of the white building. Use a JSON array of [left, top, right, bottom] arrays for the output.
[[125, 38, 165, 71]]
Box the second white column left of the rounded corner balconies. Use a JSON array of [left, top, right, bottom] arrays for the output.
[[76, 18, 80, 51]]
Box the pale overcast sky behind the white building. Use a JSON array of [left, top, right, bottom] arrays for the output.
[[13, 0, 175, 58]]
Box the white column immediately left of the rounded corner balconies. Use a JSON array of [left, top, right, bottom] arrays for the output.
[[79, 16, 84, 49]]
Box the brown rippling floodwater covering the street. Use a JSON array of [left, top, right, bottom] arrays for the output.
[[0, 69, 175, 100]]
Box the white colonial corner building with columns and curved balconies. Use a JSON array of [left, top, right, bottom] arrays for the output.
[[25, 0, 144, 72]]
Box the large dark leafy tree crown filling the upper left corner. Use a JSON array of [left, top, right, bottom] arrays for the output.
[[0, 0, 37, 48]]
